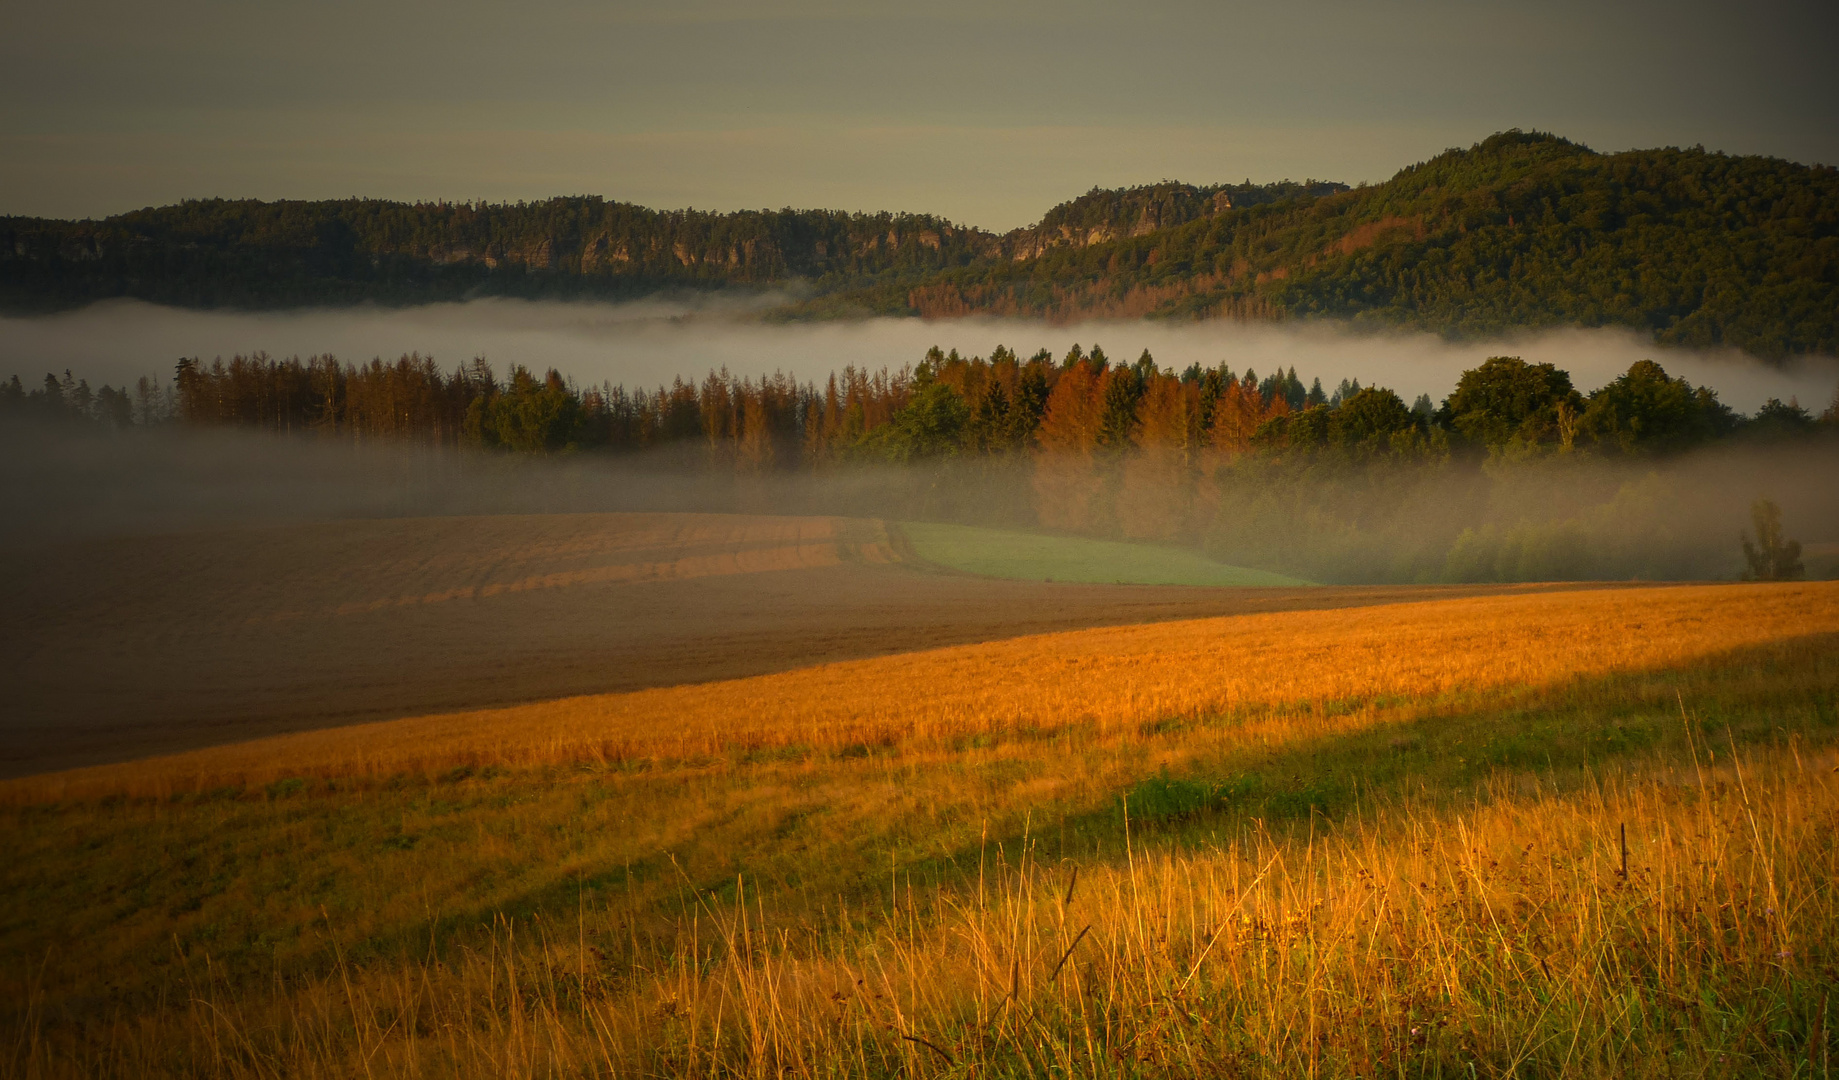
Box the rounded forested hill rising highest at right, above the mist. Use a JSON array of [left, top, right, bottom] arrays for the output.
[[871, 132, 1839, 357]]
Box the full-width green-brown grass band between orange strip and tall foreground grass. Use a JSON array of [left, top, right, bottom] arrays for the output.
[[0, 633, 1839, 1014]]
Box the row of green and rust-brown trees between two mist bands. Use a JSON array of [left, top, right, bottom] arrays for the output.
[[0, 344, 1839, 469]]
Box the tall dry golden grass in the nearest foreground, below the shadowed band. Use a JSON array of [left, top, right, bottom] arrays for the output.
[[13, 751, 1839, 1076]]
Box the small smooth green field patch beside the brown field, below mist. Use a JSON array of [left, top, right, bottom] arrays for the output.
[[901, 521, 1309, 585]]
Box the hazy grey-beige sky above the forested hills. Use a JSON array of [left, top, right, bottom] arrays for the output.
[[0, 0, 1839, 228]]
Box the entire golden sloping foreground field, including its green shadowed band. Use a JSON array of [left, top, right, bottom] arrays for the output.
[[0, 583, 1839, 1076]]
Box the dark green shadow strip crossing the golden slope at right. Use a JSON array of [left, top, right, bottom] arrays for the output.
[[1068, 635, 1839, 844]]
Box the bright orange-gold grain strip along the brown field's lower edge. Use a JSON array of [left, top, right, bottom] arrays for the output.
[[0, 583, 1839, 802]]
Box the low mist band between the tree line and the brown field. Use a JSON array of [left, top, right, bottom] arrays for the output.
[[0, 413, 1839, 583]]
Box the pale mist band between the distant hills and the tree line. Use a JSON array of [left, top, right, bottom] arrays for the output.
[[0, 291, 1839, 412]]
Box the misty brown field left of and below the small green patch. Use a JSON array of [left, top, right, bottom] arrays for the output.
[[0, 513, 1603, 776]]
